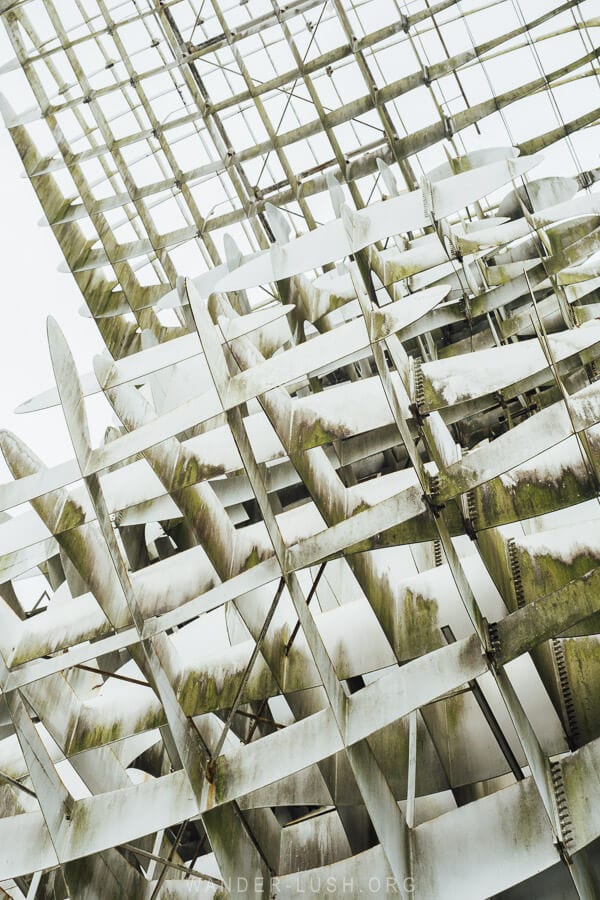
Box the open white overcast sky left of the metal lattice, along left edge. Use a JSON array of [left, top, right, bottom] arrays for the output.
[[0, 27, 102, 481]]
